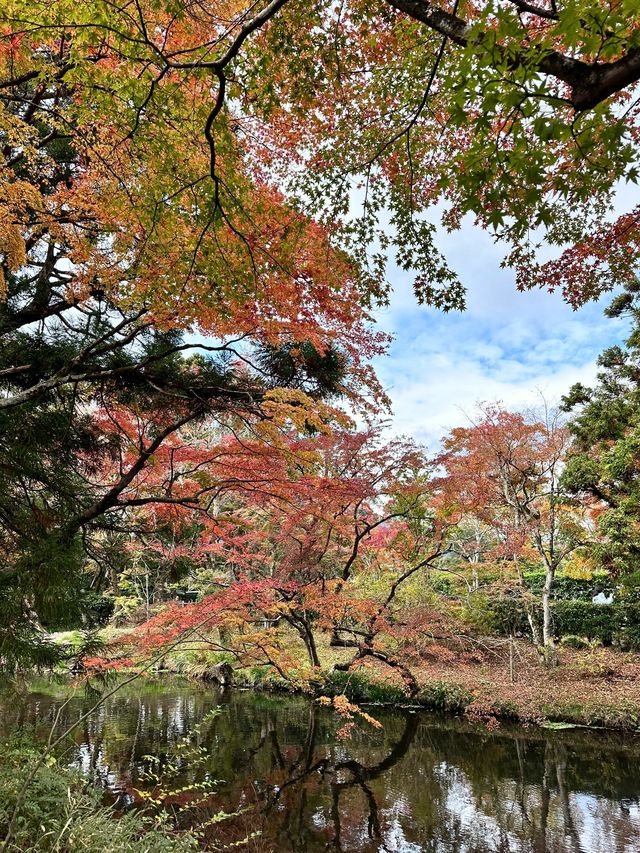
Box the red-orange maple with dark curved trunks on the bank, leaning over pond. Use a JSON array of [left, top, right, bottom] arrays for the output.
[[105, 430, 444, 691]]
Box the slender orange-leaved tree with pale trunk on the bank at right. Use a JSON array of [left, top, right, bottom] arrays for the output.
[[439, 406, 585, 661]]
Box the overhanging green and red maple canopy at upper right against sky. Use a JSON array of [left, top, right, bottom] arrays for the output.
[[241, 0, 640, 308]]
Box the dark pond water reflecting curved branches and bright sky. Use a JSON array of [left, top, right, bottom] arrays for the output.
[[0, 685, 640, 853]]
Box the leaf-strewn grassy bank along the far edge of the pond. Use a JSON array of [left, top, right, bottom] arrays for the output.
[[159, 638, 640, 731]]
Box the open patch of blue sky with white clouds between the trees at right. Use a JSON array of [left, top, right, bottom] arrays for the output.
[[376, 216, 625, 450]]
